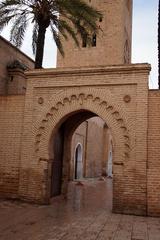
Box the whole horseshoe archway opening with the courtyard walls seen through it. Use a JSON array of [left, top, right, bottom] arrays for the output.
[[50, 110, 113, 211]]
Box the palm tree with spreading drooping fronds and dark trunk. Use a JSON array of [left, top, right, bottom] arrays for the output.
[[0, 0, 102, 68]]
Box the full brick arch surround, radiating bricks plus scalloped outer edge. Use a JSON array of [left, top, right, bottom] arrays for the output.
[[35, 93, 130, 164]]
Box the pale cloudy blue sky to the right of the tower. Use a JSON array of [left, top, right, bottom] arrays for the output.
[[132, 0, 158, 88]]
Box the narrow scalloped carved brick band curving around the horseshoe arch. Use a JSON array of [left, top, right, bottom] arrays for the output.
[[35, 93, 130, 165]]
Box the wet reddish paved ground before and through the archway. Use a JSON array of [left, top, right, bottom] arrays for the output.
[[0, 179, 160, 240]]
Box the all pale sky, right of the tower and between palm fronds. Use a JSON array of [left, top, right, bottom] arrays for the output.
[[3, 0, 158, 88]]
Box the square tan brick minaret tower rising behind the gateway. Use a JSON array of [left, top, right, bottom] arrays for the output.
[[57, 0, 132, 67]]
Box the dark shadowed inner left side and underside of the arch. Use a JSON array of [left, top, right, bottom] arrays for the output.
[[51, 110, 96, 197]]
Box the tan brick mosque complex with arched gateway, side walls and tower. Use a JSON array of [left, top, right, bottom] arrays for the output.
[[0, 0, 160, 216]]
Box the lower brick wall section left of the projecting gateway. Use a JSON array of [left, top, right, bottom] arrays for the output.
[[0, 96, 24, 197]]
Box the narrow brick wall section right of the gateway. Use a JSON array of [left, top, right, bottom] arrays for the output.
[[147, 90, 160, 216]]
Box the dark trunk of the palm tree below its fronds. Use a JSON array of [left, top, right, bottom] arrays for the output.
[[35, 24, 46, 68]]
